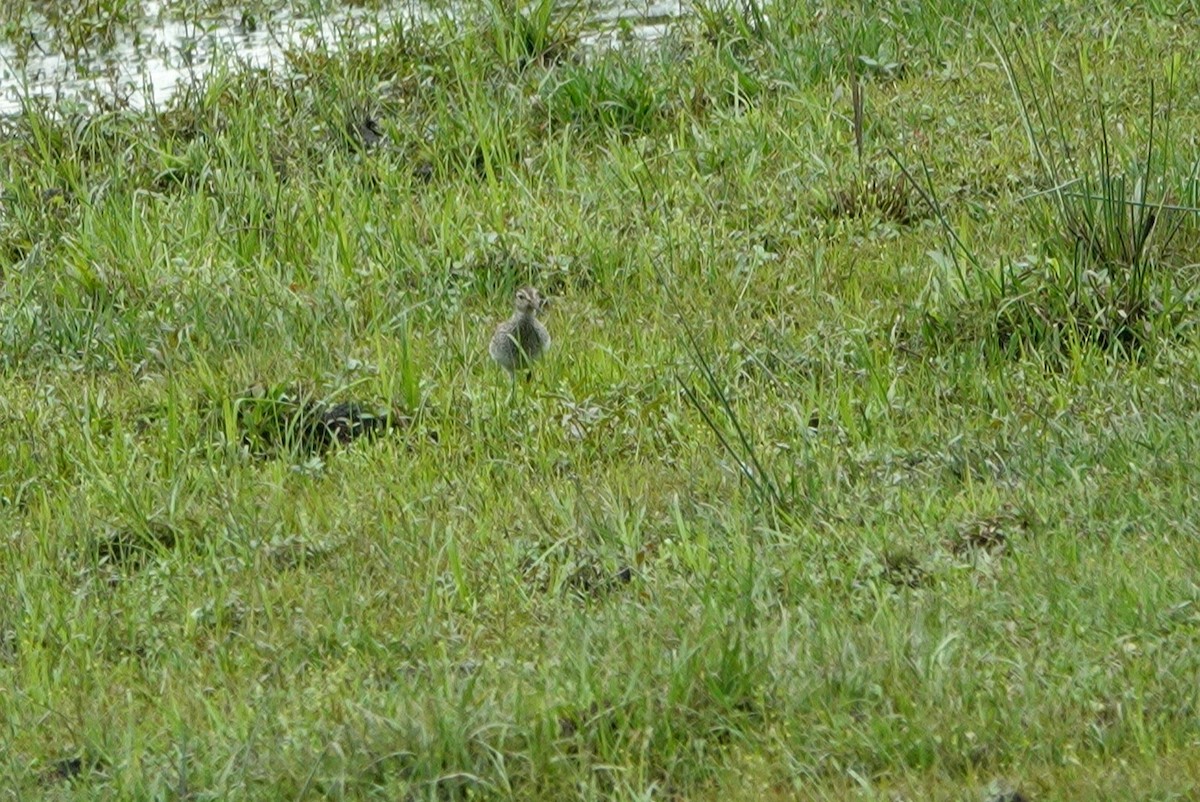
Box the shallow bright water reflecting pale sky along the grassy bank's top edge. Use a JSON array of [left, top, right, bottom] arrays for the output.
[[0, 0, 688, 115]]
